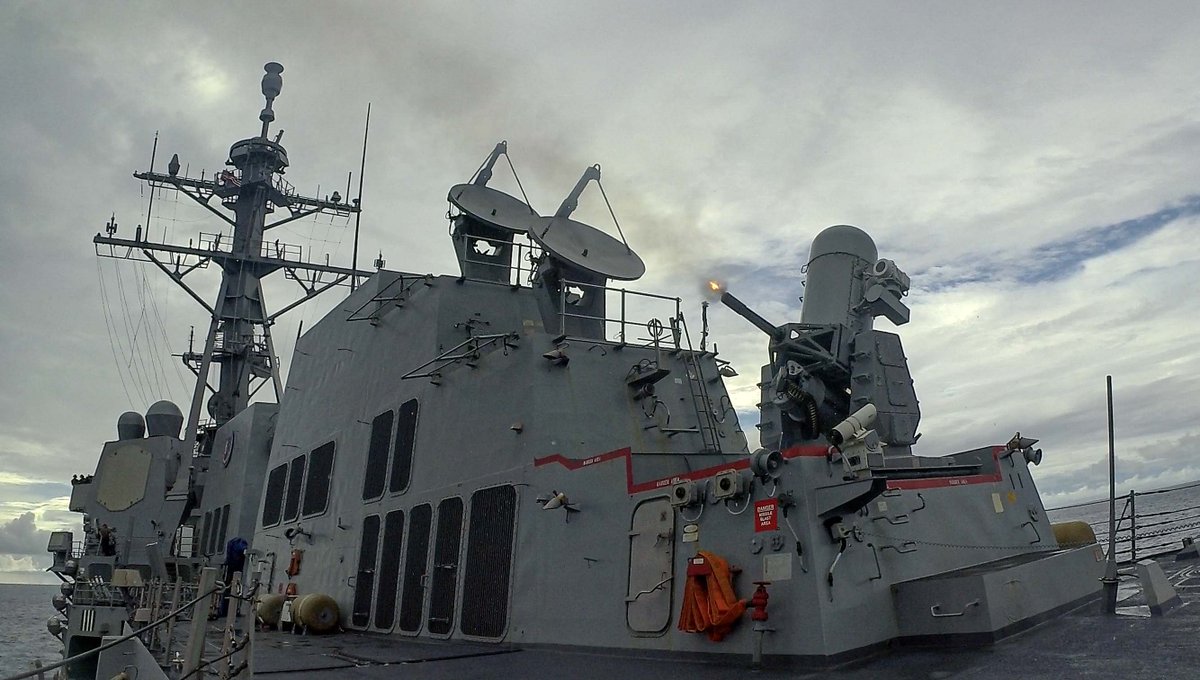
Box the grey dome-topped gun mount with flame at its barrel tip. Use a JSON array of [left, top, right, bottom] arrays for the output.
[[721, 224, 920, 457]]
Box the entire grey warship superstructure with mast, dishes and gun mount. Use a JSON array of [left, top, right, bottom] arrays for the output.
[[32, 62, 1132, 680]]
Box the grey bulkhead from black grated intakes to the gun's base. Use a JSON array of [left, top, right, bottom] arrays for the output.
[[246, 268, 1099, 657]]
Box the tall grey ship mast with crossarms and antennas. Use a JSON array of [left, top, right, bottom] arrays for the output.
[[92, 61, 370, 467]]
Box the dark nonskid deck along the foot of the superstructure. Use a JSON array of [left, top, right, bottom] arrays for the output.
[[254, 561, 1200, 680]]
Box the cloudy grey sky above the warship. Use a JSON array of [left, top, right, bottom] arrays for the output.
[[0, 0, 1200, 582]]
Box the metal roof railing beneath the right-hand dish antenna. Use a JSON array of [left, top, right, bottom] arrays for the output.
[[558, 279, 686, 350]]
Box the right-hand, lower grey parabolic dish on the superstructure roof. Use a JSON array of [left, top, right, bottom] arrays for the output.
[[529, 217, 646, 281]]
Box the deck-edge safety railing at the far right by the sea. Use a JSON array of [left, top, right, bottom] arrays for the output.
[[1048, 482, 1200, 564]]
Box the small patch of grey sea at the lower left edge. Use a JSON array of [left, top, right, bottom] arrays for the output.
[[0, 583, 62, 676]]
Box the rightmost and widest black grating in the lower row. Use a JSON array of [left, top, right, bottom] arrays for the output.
[[458, 486, 517, 638]]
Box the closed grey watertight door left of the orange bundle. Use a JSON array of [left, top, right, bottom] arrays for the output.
[[625, 498, 674, 633]]
